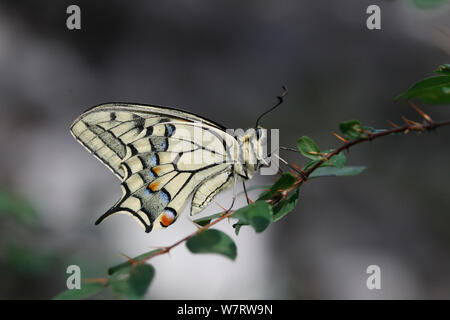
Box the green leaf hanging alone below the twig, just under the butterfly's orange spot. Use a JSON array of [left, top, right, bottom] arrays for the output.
[[186, 229, 237, 260]]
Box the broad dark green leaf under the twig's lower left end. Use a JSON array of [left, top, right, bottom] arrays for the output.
[[109, 264, 155, 300]]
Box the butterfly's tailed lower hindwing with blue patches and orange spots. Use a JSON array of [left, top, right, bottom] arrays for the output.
[[97, 154, 231, 232]]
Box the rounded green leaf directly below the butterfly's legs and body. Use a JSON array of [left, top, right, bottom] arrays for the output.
[[232, 200, 273, 232]]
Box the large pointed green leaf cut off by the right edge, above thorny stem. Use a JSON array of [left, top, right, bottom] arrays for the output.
[[394, 75, 450, 104]]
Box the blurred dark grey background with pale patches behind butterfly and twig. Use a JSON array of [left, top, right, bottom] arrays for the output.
[[0, 0, 450, 299]]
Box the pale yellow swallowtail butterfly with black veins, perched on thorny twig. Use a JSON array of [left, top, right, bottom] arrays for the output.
[[70, 101, 282, 232]]
